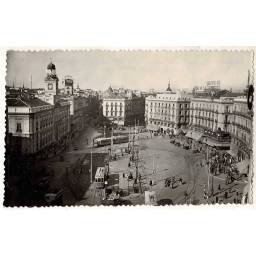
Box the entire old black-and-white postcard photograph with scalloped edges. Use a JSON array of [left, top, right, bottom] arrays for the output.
[[4, 50, 255, 207]]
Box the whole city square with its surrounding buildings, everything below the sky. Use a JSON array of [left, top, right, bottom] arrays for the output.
[[7, 62, 253, 205]]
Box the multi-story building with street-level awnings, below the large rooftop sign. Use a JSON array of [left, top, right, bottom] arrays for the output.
[[187, 92, 246, 149]]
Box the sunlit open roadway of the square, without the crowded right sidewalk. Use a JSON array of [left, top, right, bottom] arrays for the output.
[[107, 136, 207, 204]]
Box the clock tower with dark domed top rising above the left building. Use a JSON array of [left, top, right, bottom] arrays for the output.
[[44, 62, 59, 95]]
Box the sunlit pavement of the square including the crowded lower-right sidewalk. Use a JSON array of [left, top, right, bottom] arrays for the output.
[[107, 136, 245, 204]]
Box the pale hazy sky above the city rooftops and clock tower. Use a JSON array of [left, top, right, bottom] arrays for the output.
[[7, 51, 252, 90]]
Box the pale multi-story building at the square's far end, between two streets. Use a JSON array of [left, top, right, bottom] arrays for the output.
[[102, 86, 145, 126]]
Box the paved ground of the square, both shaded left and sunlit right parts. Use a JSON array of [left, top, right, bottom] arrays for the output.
[[40, 128, 248, 205]]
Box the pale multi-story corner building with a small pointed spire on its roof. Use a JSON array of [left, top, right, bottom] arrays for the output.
[[145, 83, 190, 133]]
